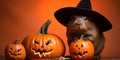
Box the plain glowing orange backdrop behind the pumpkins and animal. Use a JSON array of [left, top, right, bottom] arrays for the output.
[[0, 0, 120, 57]]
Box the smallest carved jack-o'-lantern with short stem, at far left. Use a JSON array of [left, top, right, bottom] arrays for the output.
[[5, 40, 26, 60]]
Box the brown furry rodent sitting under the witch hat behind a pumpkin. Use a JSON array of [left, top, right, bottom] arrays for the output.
[[67, 16, 105, 56]]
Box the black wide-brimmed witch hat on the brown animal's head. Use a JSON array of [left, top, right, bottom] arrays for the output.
[[54, 0, 112, 32]]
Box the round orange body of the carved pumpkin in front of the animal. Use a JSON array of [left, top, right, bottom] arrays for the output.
[[70, 40, 94, 59]]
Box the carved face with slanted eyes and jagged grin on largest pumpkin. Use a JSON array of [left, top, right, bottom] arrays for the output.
[[31, 36, 56, 57]]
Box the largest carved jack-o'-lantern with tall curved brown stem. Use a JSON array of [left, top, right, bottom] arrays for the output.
[[23, 20, 65, 59]]
